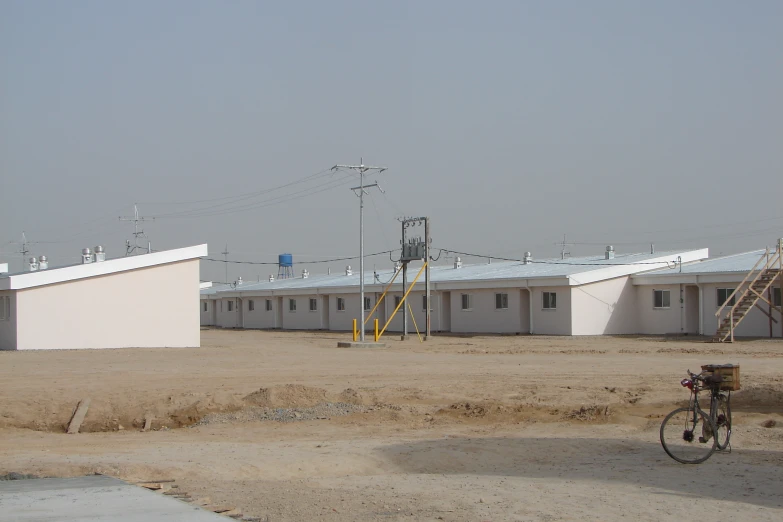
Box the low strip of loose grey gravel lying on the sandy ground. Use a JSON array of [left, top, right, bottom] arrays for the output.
[[194, 402, 374, 426]]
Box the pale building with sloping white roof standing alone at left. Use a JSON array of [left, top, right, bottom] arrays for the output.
[[0, 245, 207, 350]]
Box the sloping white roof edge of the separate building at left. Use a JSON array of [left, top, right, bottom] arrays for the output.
[[0, 244, 207, 290]]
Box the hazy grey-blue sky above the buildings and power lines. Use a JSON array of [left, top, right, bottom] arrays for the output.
[[0, 0, 783, 280]]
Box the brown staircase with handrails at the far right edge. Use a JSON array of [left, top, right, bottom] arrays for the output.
[[713, 239, 783, 343]]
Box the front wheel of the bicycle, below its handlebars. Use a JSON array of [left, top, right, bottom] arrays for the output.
[[661, 408, 718, 464]]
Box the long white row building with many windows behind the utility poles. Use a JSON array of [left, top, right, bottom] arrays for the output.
[[201, 249, 709, 335]]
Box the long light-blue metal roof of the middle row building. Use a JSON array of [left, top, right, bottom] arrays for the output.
[[207, 250, 706, 295]]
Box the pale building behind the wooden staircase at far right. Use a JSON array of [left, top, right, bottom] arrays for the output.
[[632, 250, 783, 337]]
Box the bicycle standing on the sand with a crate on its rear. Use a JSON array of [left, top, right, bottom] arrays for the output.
[[660, 370, 731, 464]]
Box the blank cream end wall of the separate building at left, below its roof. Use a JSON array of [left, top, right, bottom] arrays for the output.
[[16, 259, 201, 350]]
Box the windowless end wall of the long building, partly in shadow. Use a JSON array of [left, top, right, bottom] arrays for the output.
[[572, 276, 640, 335]]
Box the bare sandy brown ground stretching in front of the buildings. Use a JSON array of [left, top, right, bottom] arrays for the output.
[[0, 330, 783, 522]]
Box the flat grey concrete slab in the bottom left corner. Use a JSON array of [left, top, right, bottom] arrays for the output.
[[0, 475, 230, 522]]
